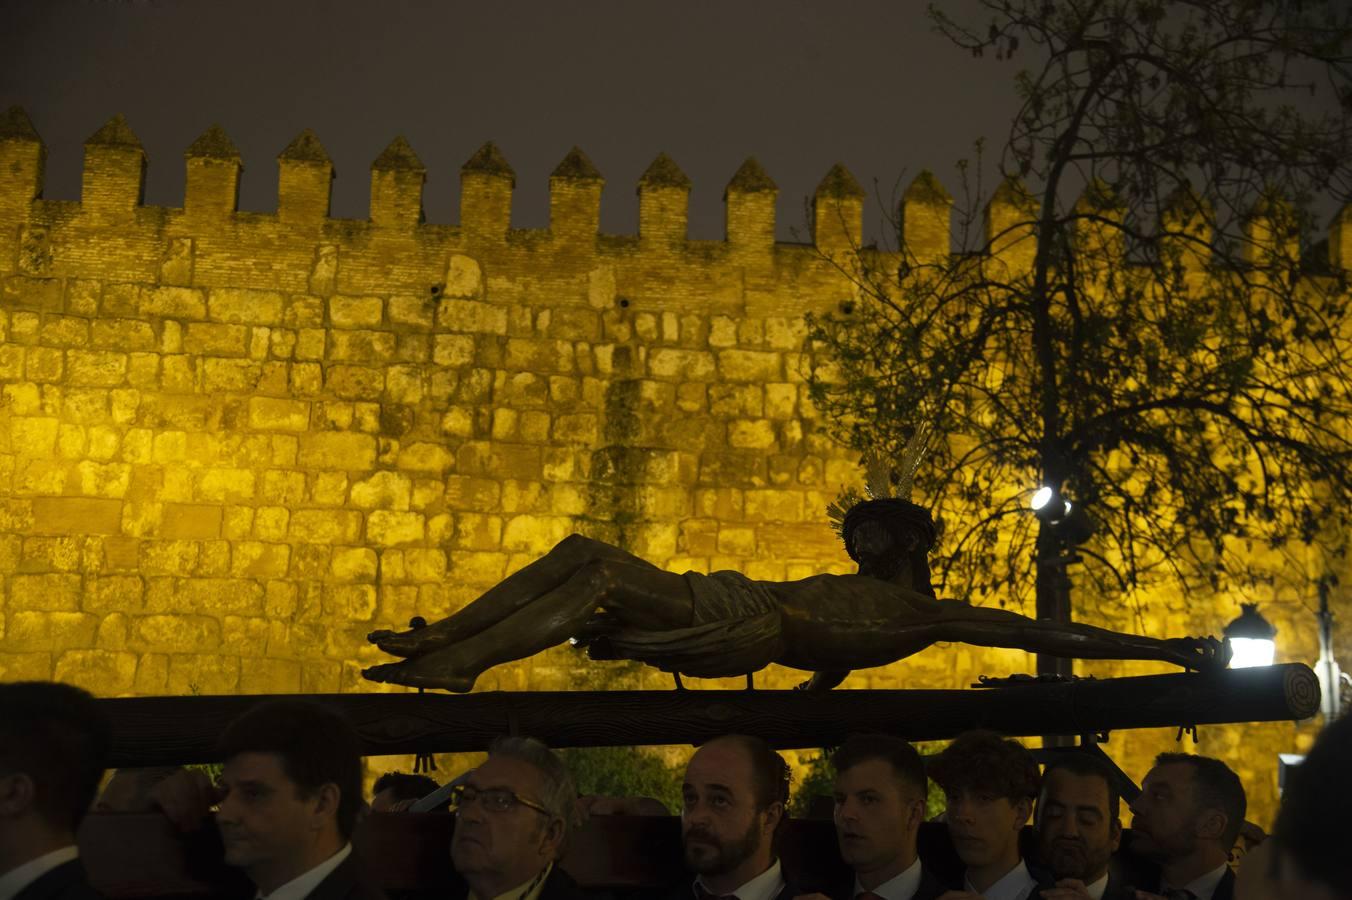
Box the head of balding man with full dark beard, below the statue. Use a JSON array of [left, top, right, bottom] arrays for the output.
[[676, 734, 800, 900]]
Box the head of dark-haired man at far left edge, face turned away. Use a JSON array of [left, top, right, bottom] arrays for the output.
[[0, 681, 110, 900]]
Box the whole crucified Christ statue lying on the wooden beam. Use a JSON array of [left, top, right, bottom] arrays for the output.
[[362, 499, 1229, 692]]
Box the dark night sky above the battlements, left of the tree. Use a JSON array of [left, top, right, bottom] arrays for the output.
[[0, 0, 1015, 239]]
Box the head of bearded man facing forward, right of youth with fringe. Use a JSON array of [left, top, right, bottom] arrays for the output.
[[1034, 753, 1134, 900]]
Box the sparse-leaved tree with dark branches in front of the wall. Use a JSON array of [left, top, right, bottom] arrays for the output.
[[811, 0, 1352, 662]]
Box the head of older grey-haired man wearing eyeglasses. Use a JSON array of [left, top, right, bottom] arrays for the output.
[[450, 738, 585, 900]]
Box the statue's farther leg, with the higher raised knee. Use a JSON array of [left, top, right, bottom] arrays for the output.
[[366, 534, 654, 657]]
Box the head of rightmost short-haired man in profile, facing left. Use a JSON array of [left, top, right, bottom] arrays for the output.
[[1132, 753, 1245, 900]]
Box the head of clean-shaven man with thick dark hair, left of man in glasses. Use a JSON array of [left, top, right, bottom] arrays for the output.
[[216, 700, 385, 900]]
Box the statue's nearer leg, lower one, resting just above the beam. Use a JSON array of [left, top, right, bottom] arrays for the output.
[[362, 559, 694, 692]]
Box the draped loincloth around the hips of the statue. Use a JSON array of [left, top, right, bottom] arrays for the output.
[[578, 572, 784, 678]]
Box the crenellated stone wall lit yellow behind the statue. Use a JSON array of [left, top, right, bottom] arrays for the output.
[[0, 109, 1352, 819]]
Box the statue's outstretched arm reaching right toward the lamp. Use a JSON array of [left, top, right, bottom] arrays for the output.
[[927, 601, 1229, 669]]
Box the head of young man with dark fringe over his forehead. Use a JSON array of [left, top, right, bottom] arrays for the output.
[[930, 731, 1052, 900]]
